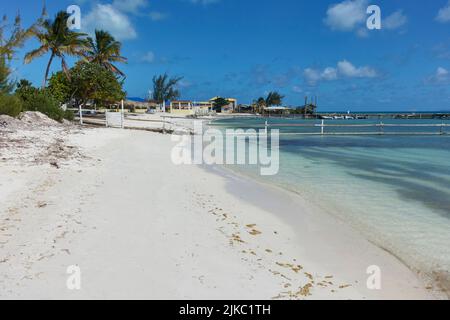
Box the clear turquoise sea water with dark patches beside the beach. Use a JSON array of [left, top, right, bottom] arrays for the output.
[[210, 119, 450, 284]]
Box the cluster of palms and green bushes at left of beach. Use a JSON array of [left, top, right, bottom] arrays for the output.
[[0, 9, 127, 121]]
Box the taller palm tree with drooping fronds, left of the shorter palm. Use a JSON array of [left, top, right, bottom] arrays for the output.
[[25, 11, 87, 88]]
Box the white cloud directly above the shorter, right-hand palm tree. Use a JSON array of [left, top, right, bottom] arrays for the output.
[[82, 4, 137, 40]]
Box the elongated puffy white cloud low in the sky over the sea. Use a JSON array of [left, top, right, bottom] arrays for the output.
[[303, 60, 378, 85]]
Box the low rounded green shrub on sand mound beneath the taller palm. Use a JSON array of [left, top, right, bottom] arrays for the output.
[[23, 91, 65, 122]]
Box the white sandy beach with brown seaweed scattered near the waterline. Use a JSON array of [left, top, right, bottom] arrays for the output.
[[0, 119, 438, 299]]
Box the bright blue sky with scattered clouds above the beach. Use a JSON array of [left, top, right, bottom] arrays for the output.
[[1, 0, 450, 111]]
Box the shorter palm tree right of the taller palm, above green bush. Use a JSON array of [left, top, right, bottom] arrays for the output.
[[86, 30, 127, 77]]
